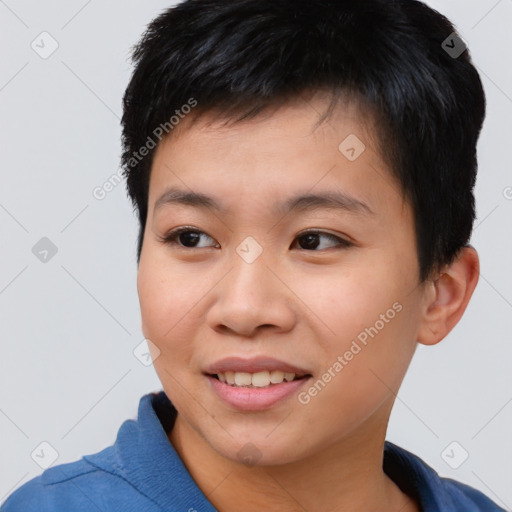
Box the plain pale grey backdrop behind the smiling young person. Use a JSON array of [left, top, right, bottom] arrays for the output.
[[0, 0, 512, 510]]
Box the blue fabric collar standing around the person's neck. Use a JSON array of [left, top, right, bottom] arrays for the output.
[[83, 391, 464, 512]]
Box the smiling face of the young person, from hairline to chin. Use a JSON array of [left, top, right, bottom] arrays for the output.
[[137, 97, 423, 464]]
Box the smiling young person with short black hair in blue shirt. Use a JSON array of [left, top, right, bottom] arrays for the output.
[[2, 0, 503, 512]]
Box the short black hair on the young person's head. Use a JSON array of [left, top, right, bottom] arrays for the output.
[[121, 0, 486, 282]]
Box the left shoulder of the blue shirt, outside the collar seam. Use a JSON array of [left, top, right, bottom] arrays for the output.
[[0, 459, 148, 512]]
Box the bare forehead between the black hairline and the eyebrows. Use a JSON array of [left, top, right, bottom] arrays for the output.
[[149, 95, 406, 222]]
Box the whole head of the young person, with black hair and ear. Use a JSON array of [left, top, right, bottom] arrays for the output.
[[122, 0, 485, 464]]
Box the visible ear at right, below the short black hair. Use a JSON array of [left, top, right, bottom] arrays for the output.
[[417, 245, 480, 345]]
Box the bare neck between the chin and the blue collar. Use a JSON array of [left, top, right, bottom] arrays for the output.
[[168, 415, 420, 512]]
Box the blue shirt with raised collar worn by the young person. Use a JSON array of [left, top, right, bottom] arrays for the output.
[[1, 391, 505, 512]]
